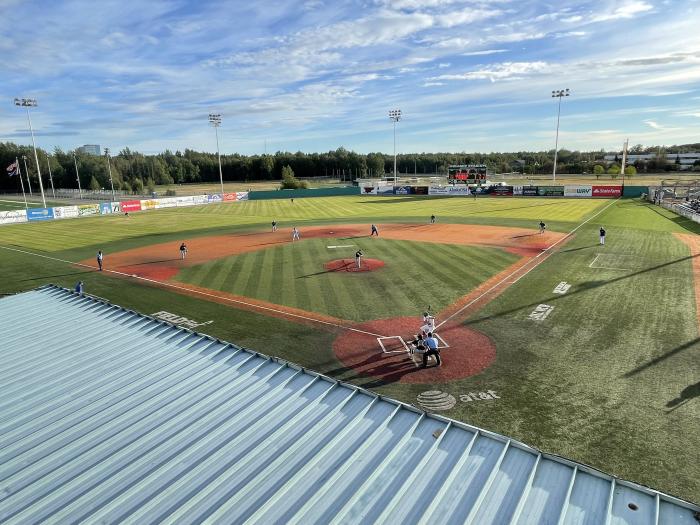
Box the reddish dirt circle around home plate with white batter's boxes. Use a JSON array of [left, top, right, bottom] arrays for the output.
[[333, 317, 496, 383]]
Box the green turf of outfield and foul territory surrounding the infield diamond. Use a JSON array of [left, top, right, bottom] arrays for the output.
[[0, 196, 700, 501]]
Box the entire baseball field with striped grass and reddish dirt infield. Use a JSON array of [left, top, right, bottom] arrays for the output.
[[0, 196, 700, 502]]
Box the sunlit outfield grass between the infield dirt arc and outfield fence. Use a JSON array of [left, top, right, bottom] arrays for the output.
[[0, 196, 607, 255]]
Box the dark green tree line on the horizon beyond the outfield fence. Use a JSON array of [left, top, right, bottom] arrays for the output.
[[0, 142, 700, 193]]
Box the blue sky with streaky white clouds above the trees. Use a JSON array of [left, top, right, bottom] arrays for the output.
[[0, 0, 700, 154]]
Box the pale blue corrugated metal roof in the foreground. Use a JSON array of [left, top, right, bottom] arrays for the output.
[[0, 287, 698, 525]]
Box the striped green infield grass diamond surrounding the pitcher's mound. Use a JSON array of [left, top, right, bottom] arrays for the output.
[[172, 237, 519, 321]]
